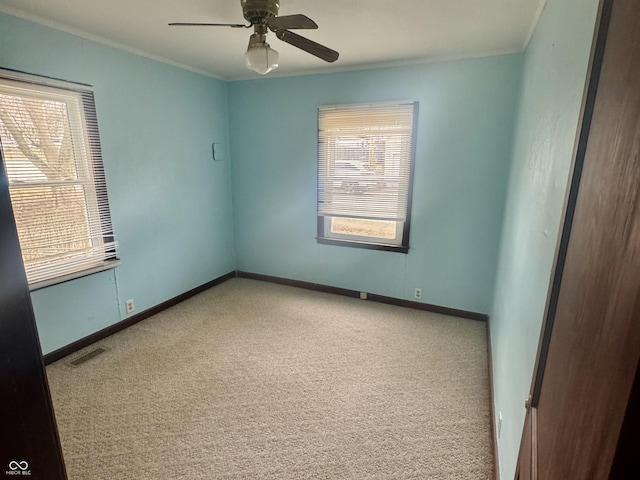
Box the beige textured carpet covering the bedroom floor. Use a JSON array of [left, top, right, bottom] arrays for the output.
[[47, 279, 493, 480]]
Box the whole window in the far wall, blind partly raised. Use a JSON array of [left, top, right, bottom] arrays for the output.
[[318, 102, 418, 253]]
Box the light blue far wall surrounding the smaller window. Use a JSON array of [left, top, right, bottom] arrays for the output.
[[229, 55, 522, 313]]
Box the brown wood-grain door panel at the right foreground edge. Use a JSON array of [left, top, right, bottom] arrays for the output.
[[538, 0, 640, 480]]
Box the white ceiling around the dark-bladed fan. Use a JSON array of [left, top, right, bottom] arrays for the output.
[[0, 0, 546, 80]]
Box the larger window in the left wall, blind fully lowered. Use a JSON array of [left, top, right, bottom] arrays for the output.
[[0, 70, 117, 290]]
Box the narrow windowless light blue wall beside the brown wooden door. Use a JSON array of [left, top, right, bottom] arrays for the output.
[[491, 0, 598, 479]]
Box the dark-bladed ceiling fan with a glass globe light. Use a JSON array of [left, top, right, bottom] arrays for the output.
[[169, 0, 339, 75]]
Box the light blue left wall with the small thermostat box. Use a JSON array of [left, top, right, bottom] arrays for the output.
[[0, 14, 235, 353]]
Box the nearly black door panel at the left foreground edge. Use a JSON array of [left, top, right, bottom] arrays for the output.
[[0, 147, 67, 480]]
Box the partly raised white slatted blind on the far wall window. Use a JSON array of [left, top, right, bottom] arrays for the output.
[[318, 102, 416, 222]]
